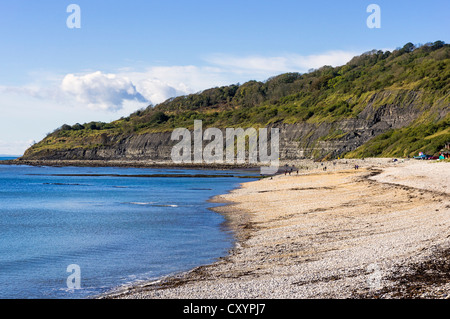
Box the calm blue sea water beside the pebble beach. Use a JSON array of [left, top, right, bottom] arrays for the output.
[[0, 165, 256, 298]]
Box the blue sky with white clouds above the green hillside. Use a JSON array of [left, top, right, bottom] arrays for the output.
[[0, 0, 450, 155]]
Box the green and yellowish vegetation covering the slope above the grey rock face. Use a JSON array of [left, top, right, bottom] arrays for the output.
[[25, 41, 450, 157]]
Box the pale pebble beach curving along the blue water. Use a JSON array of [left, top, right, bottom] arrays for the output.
[[100, 159, 450, 299]]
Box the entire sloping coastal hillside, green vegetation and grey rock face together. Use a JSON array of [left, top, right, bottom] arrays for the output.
[[22, 41, 450, 160]]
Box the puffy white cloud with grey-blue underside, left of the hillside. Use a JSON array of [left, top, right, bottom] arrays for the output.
[[61, 71, 147, 111]]
